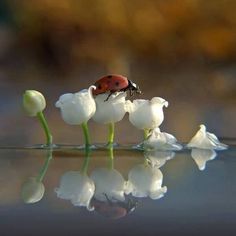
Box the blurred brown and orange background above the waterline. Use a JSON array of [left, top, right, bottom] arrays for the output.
[[0, 0, 236, 145]]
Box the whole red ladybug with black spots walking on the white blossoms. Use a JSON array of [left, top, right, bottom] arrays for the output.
[[93, 75, 141, 101]]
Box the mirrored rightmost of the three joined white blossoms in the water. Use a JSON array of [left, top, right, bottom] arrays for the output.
[[126, 164, 167, 199]]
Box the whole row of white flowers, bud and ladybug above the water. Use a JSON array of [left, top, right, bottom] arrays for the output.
[[23, 75, 227, 151]]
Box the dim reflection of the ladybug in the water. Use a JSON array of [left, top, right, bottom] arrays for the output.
[[91, 194, 137, 219]]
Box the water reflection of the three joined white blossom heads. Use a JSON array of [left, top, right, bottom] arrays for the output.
[[55, 153, 167, 211]]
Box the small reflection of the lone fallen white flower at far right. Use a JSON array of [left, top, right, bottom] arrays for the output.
[[191, 148, 217, 170]]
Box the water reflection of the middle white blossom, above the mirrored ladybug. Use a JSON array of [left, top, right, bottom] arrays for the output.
[[91, 168, 126, 201]]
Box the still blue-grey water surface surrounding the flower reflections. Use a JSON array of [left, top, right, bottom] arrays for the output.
[[0, 145, 236, 235]]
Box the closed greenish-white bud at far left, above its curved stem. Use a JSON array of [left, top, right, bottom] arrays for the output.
[[23, 90, 46, 116]]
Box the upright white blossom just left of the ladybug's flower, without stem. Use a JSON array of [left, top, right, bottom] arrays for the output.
[[56, 86, 96, 125]]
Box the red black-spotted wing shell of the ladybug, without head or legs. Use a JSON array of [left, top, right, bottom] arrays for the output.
[[93, 75, 129, 95]]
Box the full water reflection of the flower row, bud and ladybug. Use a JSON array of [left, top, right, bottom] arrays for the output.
[[21, 147, 223, 207]]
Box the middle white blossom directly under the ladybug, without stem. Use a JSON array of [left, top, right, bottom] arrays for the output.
[[93, 92, 126, 124]]
